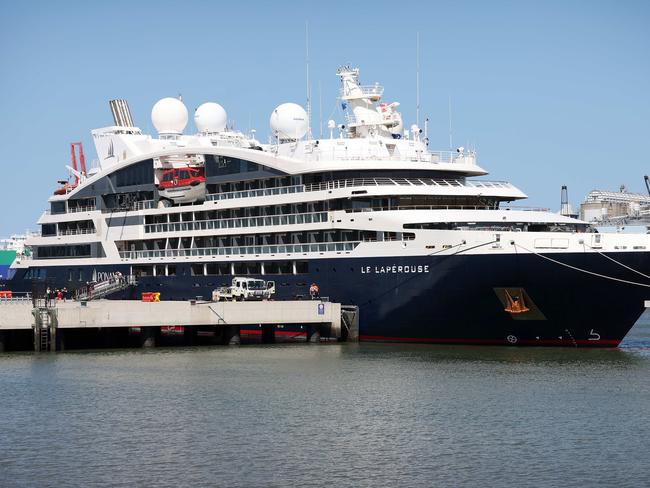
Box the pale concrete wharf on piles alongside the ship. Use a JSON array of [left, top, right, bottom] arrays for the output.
[[0, 297, 358, 351]]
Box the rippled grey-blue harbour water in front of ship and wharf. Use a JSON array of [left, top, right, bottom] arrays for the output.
[[0, 311, 650, 487]]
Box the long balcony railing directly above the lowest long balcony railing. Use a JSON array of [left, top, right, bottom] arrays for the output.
[[144, 212, 327, 233]]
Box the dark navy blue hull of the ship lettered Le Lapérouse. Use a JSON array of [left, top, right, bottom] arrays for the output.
[[2, 252, 650, 347]]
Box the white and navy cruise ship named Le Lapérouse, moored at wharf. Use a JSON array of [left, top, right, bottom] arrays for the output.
[[5, 66, 650, 347]]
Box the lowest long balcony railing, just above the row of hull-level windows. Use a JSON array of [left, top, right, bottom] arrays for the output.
[[120, 241, 360, 260]]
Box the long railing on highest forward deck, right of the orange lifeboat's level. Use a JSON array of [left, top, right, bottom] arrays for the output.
[[305, 178, 514, 191]]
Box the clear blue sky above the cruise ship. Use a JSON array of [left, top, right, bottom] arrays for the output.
[[0, 0, 650, 236]]
